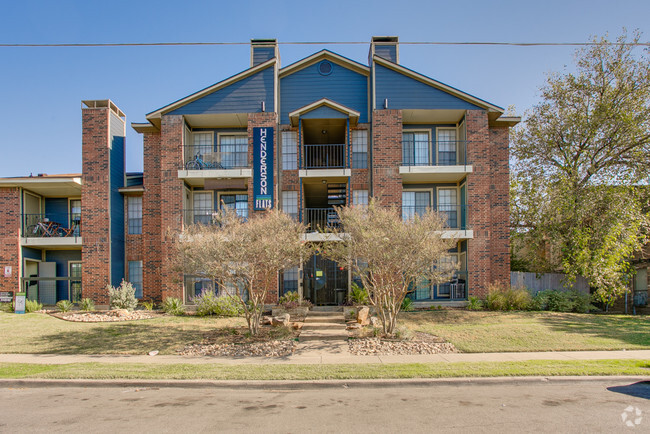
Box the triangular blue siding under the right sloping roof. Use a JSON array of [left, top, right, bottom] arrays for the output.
[[375, 64, 481, 110]]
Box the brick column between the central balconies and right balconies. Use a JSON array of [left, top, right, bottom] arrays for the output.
[[370, 110, 402, 207]]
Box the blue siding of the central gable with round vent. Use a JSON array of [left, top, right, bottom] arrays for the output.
[[280, 62, 368, 124]]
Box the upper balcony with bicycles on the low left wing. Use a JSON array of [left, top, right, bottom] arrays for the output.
[[21, 213, 82, 247]]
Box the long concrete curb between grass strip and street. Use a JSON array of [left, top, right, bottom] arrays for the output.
[[0, 375, 650, 390]]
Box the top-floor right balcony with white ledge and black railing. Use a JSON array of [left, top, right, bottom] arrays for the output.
[[399, 140, 473, 182]]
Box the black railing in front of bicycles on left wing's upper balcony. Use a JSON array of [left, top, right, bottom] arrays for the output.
[[21, 213, 81, 238]]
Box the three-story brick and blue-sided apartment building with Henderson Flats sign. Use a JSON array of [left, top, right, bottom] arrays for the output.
[[0, 37, 519, 305]]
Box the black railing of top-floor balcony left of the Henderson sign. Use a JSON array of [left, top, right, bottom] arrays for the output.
[[184, 144, 249, 170]]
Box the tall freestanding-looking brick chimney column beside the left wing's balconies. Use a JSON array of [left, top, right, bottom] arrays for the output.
[[81, 107, 111, 305]]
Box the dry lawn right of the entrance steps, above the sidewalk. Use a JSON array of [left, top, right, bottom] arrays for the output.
[[399, 310, 650, 353]]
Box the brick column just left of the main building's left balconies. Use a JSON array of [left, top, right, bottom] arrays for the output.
[[158, 115, 183, 299]]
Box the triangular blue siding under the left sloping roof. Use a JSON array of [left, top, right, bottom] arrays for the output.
[[169, 66, 275, 115]]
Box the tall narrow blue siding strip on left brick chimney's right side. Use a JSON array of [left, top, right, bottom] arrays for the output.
[[110, 136, 124, 286]]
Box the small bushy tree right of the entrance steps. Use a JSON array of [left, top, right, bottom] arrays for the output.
[[324, 199, 457, 336]]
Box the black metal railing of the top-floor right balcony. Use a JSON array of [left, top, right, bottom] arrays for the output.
[[402, 140, 468, 166]]
